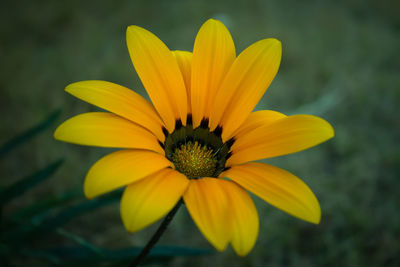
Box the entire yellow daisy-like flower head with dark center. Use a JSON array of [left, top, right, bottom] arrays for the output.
[[54, 19, 334, 256]]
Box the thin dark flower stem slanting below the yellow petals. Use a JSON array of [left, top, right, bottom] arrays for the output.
[[129, 199, 183, 267]]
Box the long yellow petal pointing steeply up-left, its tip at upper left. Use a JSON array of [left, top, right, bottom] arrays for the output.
[[126, 26, 187, 132]]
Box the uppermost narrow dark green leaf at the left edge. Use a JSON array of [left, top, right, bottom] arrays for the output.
[[0, 109, 61, 158]]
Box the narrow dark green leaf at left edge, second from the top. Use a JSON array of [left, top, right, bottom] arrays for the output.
[[0, 159, 63, 205]]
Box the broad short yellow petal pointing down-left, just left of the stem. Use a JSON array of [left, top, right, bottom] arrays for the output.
[[121, 168, 189, 233]]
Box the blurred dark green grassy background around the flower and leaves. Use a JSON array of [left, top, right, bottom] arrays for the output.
[[0, 0, 400, 266]]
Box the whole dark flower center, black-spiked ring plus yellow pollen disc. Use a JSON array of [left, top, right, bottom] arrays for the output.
[[161, 114, 234, 179]]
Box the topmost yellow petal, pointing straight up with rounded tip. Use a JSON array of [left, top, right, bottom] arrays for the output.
[[191, 19, 236, 127]]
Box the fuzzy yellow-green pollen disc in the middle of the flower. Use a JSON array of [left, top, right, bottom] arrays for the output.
[[172, 141, 218, 179]]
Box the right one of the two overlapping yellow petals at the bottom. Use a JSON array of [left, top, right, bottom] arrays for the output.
[[223, 181, 259, 256]]
